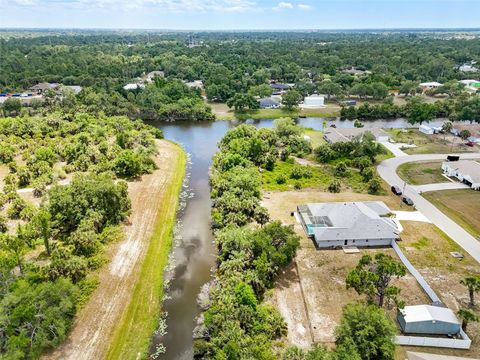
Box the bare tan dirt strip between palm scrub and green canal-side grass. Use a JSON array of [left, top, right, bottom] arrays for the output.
[[43, 140, 184, 360]]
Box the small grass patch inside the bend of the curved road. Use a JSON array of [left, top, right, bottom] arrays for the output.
[[397, 161, 448, 185]]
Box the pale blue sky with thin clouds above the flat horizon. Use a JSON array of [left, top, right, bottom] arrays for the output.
[[0, 0, 480, 30]]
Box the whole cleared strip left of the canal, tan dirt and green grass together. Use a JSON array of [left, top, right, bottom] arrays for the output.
[[45, 140, 185, 360]]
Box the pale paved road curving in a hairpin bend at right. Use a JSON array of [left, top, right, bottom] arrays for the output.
[[378, 153, 480, 263]]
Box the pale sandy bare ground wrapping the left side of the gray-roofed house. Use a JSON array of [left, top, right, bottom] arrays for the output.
[[263, 191, 428, 347]]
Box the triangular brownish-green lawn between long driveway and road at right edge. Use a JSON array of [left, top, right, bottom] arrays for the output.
[[422, 189, 480, 237]]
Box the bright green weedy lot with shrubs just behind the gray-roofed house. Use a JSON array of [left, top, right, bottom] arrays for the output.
[[262, 161, 368, 193]]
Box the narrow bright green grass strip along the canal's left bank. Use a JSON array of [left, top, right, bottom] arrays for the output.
[[106, 143, 186, 360]]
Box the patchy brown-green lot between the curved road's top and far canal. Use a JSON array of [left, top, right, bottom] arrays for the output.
[[387, 129, 478, 154]]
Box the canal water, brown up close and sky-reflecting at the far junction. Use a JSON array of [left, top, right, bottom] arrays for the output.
[[147, 118, 446, 360]]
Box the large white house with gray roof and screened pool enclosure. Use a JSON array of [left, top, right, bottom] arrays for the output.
[[297, 201, 399, 248]]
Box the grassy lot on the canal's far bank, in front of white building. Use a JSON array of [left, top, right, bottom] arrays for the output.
[[208, 103, 340, 120]]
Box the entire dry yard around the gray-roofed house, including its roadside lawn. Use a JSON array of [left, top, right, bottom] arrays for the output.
[[263, 191, 480, 359]]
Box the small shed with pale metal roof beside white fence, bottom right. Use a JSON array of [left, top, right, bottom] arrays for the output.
[[397, 305, 461, 335]]
